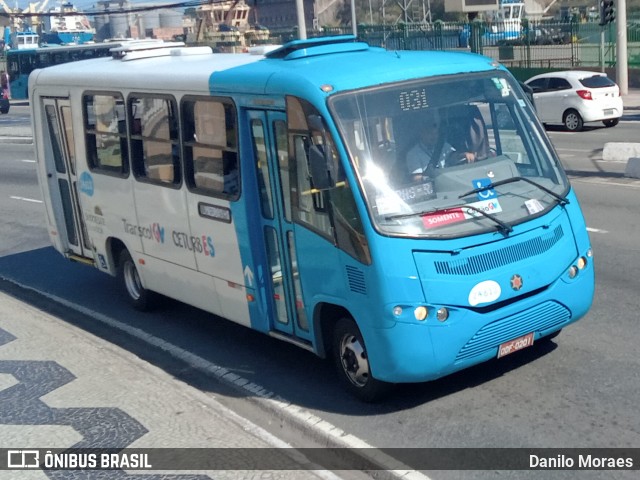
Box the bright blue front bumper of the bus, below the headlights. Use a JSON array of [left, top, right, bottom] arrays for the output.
[[365, 265, 595, 383]]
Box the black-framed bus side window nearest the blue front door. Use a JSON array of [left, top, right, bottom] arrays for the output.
[[182, 97, 240, 200]]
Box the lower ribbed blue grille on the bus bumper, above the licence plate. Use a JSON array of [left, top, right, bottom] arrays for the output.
[[455, 301, 571, 362]]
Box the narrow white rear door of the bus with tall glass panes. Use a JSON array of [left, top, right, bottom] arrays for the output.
[[42, 98, 93, 257]]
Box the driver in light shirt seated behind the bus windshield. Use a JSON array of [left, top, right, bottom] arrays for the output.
[[407, 108, 475, 181]]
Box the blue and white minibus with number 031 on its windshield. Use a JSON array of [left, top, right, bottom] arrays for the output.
[[29, 37, 594, 401]]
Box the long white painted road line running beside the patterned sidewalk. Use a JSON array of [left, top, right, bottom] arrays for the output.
[[5, 278, 431, 480]]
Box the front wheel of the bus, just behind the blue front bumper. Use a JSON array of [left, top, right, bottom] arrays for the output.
[[331, 318, 392, 403]]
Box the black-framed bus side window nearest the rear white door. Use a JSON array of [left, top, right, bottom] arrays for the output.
[[83, 93, 129, 176]]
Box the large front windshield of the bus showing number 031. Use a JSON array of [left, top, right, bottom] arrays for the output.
[[329, 71, 568, 237]]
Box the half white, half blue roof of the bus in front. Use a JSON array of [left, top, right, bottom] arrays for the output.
[[31, 37, 497, 101]]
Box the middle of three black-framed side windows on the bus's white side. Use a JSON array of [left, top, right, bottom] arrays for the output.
[[128, 95, 181, 185]]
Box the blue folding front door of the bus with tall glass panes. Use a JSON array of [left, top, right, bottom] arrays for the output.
[[249, 111, 311, 340]]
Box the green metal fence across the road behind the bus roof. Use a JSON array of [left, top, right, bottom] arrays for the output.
[[270, 19, 640, 75]]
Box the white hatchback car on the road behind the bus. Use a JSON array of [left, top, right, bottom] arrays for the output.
[[524, 70, 623, 132]]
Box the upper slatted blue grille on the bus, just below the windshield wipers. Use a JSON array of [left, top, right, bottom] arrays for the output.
[[434, 225, 564, 275]]
